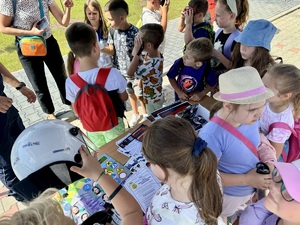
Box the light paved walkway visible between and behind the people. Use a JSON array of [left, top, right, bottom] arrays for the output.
[[0, 0, 300, 218]]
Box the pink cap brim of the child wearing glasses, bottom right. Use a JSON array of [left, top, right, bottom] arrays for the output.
[[270, 162, 300, 202]]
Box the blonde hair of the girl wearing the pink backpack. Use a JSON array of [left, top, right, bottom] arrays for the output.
[[267, 64, 300, 116]]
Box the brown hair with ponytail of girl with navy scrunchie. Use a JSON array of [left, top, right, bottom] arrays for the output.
[[142, 116, 222, 225]]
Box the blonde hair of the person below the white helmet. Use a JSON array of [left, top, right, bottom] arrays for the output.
[[0, 188, 75, 225]]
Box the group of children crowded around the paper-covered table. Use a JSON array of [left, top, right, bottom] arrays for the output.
[[2, 0, 300, 225]]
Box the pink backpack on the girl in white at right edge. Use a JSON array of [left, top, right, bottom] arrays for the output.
[[269, 120, 300, 162]]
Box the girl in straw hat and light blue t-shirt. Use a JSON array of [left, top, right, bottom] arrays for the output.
[[199, 67, 274, 221]]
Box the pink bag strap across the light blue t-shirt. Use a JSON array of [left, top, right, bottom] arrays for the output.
[[210, 116, 259, 159]]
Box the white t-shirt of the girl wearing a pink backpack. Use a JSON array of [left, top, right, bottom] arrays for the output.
[[260, 102, 294, 143]]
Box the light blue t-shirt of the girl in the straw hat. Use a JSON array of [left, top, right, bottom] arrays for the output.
[[199, 118, 260, 196]]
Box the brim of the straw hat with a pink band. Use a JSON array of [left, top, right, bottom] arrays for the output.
[[213, 88, 274, 105]]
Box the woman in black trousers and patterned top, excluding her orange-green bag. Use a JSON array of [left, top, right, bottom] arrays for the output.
[[0, 0, 73, 119]]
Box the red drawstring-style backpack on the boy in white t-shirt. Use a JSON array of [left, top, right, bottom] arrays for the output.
[[70, 68, 118, 132]]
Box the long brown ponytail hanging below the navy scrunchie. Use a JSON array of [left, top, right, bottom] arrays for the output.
[[190, 148, 222, 225]]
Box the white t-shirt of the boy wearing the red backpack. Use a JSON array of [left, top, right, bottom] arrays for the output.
[[66, 68, 127, 103]]
